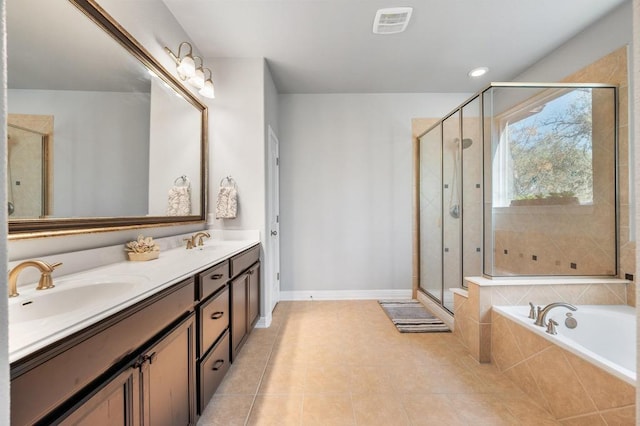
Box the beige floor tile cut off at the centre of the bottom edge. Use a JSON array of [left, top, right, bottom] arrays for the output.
[[300, 393, 356, 426]]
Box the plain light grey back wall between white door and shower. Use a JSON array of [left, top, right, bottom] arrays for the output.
[[279, 93, 469, 297]]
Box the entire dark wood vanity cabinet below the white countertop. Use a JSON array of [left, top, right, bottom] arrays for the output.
[[11, 245, 260, 426]]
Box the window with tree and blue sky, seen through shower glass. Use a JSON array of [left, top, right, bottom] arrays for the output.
[[494, 88, 593, 207]]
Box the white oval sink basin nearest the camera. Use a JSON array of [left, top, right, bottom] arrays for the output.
[[9, 275, 148, 324]]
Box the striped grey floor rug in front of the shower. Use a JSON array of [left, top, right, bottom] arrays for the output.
[[378, 300, 451, 333]]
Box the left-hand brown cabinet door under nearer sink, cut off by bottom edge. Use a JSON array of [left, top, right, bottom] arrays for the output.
[[59, 367, 140, 426]]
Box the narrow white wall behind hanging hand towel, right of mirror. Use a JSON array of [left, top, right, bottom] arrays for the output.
[[205, 58, 265, 236]]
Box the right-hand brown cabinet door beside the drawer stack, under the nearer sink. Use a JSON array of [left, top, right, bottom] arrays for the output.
[[140, 314, 196, 426]]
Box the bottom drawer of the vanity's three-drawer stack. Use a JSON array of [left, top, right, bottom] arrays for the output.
[[198, 331, 230, 413]]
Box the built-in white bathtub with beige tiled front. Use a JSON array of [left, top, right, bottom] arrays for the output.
[[491, 306, 635, 425]]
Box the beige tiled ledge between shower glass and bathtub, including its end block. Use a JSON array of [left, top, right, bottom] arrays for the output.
[[454, 277, 628, 362]]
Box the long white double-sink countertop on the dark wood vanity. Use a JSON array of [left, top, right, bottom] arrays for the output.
[[9, 233, 259, 363]]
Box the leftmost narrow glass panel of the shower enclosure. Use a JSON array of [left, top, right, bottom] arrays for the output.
[[419, 125, 442, 301]]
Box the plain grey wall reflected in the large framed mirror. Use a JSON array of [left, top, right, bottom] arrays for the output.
[[7, 90, 149, 217]]
